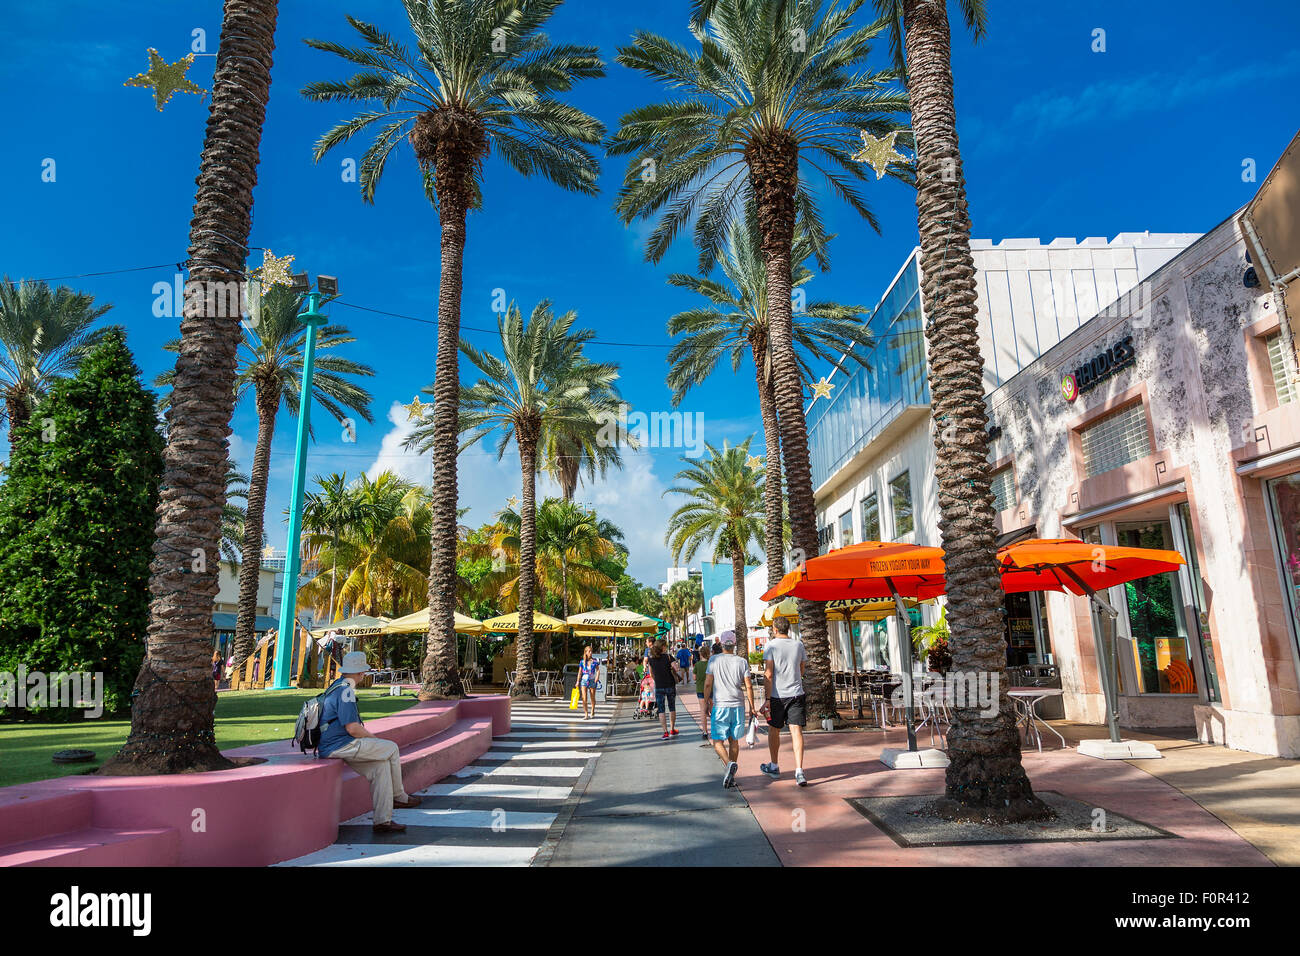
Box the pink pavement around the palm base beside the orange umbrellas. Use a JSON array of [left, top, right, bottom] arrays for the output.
[[677, 688, 1271, 866]]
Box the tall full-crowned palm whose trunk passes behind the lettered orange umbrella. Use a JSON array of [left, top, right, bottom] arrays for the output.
[[610, 0, 909, 721]]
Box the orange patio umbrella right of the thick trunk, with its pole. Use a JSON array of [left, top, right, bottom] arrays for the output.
[[997, 537, 1187, 744]]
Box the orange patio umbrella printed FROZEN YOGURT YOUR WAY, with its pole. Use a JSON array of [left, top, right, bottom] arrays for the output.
[[763, 541, 945, 752]]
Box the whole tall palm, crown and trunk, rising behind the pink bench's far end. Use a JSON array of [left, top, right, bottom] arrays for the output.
[[303, 0, 605, 700]]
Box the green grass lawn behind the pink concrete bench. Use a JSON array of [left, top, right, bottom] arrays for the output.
[[0, 688, 415, 787]]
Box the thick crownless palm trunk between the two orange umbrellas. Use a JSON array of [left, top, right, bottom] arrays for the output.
[[904, 0, 1050, 819]]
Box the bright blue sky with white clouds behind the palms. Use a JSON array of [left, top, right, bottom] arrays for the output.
[[0, 0, 1300, 584]]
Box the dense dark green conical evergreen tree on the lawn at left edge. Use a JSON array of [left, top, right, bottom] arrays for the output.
[[0, 329, 165, 713]]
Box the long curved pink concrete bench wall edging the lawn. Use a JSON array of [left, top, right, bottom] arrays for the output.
[[0, 697, 510, 866]]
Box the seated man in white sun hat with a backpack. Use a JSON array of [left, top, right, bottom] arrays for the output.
[[319, 650, 420, 834]]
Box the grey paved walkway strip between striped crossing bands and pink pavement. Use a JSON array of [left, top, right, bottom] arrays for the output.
[[550, 685, 780, 866]]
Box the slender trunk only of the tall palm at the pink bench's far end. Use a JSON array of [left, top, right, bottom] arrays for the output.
[[419, 180, 468, 700]]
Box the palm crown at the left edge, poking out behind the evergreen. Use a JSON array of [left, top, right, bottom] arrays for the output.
[[0, 276, 112, 449]]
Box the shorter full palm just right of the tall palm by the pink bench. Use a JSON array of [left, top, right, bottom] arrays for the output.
[[407, 299, 619, 695]]
